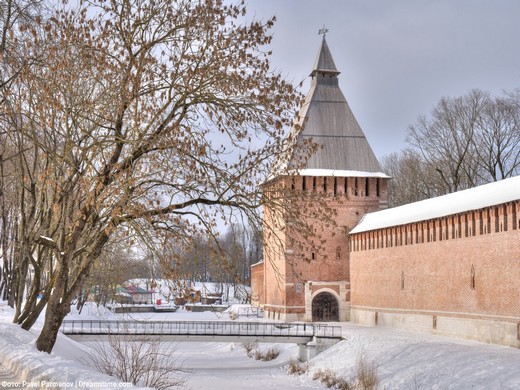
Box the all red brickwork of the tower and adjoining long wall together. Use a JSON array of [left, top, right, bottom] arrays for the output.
[[251, 169, 520, 347]]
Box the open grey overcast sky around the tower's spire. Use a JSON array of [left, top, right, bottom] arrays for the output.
[[247, 0, 520, 159]]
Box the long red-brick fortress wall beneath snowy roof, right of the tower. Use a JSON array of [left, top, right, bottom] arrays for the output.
[[350, 200, 520, 347]]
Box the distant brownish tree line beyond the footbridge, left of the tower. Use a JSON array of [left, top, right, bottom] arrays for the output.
[[75, 223, 263, 310]]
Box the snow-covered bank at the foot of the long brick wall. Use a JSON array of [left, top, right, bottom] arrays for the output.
[[311, 323, 520, 390]]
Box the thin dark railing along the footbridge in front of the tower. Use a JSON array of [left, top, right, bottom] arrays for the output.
[[61, 320, 341, 338]]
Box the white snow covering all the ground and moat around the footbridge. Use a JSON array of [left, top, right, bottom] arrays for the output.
[[0, 303, 520, 390]]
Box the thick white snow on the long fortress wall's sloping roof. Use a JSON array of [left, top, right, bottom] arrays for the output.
[[351, 176, 520, 233]]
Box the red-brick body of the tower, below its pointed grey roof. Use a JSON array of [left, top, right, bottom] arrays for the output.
[[251, 176, 387, 321]]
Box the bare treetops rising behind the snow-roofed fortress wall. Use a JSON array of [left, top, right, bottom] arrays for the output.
[[382, 89, 520, 206]]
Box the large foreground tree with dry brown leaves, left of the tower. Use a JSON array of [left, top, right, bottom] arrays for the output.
[[3, 0, 320, 352]]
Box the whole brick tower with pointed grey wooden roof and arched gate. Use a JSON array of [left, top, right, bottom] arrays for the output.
[[251, 31, 389, 321]]
